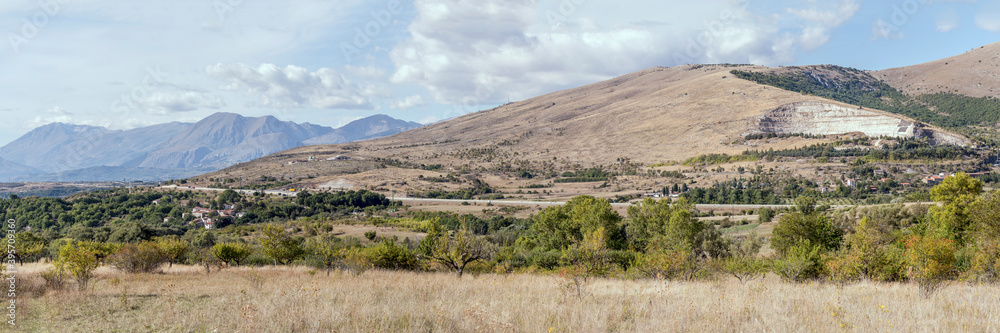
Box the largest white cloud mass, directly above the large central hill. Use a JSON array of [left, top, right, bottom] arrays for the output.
[[390, 0, 828, 105]]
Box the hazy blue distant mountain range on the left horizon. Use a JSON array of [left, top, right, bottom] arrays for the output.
[[0, 113, 422, 181]]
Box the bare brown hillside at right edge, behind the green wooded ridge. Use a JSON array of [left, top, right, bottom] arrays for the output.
[[872, 43, 1000, 97]]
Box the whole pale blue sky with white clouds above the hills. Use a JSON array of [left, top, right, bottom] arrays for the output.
[[0, 0, 1000, 145]]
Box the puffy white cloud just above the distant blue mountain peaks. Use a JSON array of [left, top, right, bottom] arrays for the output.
[[205, 63, 385, 110]]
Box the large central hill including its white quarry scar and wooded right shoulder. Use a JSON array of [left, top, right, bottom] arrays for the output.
[[192, 54, 992, 201]]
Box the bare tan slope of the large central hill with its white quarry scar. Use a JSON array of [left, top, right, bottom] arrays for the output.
[[213, 65, 964, 182]]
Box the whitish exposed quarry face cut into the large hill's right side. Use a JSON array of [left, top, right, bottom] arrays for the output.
[[748, 102, 969, 145]]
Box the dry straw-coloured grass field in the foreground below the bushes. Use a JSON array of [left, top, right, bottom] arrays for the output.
[[4, 264, 1000, 332]]
